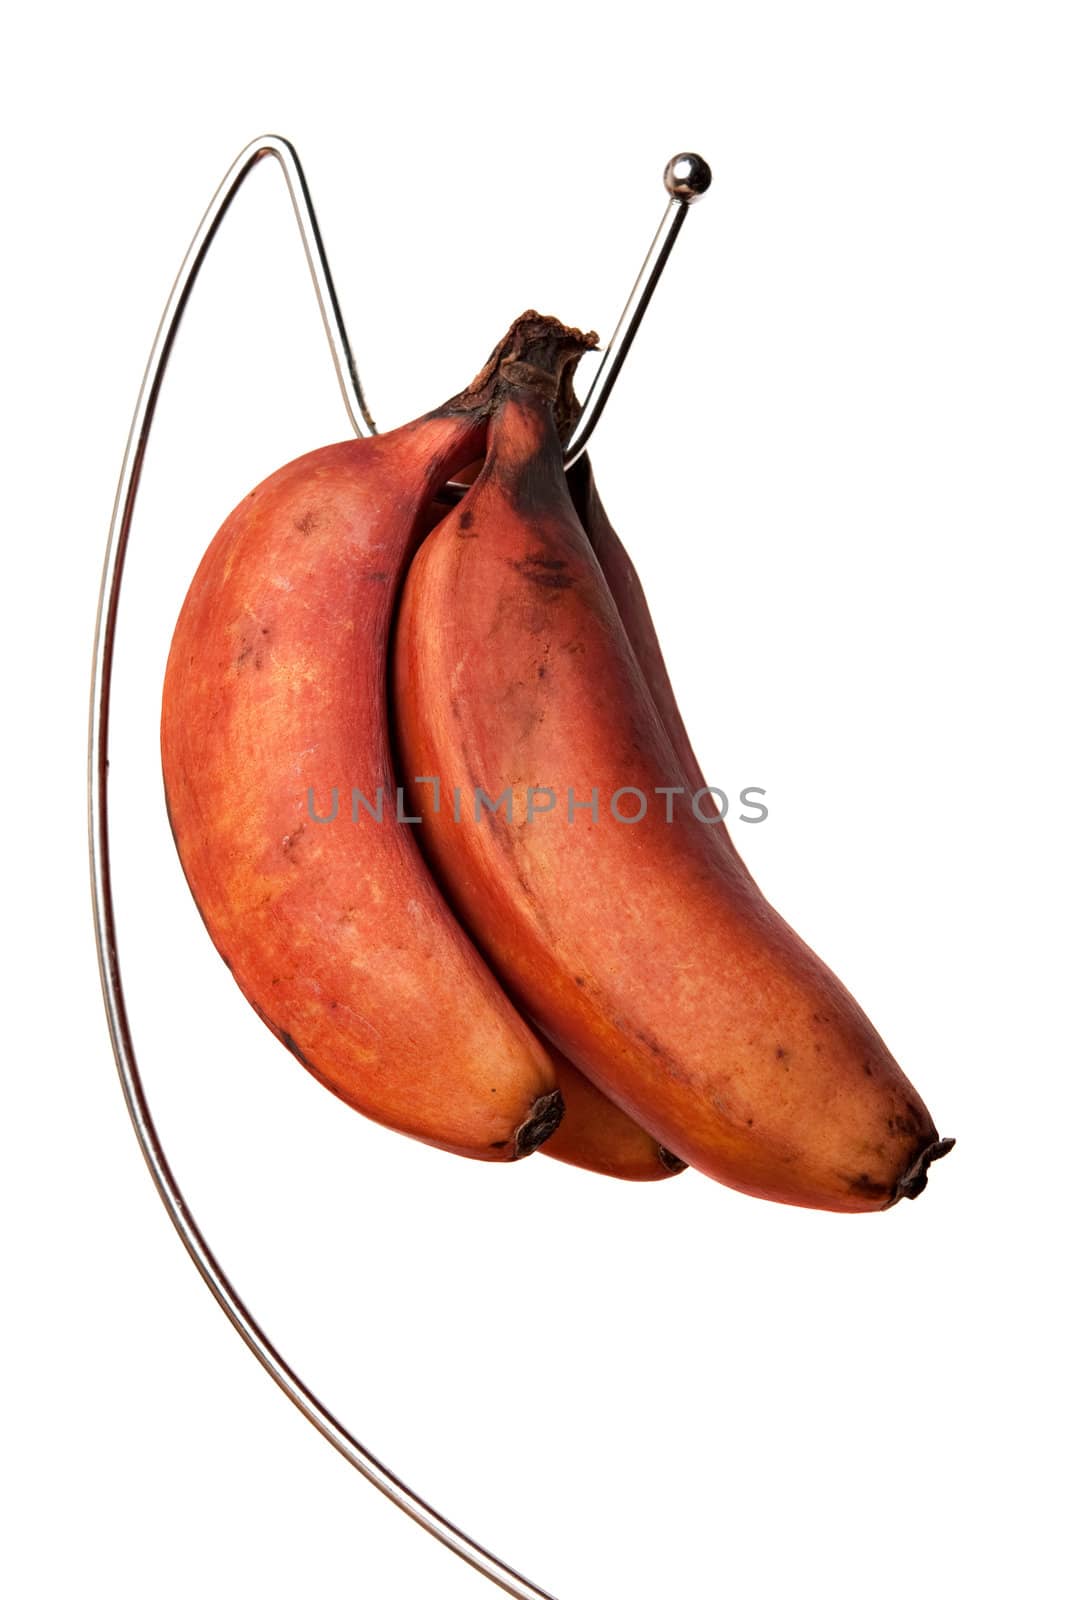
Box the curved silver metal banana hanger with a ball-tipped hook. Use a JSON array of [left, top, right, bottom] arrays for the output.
[[88, 134, 712, 1600]]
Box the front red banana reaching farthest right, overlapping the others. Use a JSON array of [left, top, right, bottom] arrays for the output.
[[394, 318, 952, 1211]]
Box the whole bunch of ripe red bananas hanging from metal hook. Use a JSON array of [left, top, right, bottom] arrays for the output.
[[162, 312, 952, 1211]]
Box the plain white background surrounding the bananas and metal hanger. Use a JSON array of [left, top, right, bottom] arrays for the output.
[[0, 0, 1067, 1600]]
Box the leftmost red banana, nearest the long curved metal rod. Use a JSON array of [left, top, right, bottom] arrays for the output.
[[162, 346, 561, 1162]]
